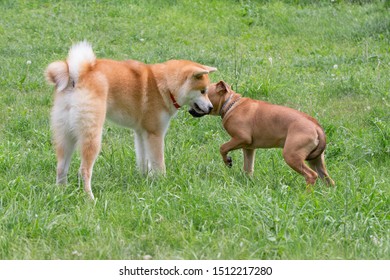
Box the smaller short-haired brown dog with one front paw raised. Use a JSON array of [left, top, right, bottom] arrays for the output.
[[204, 81, 334, 185]]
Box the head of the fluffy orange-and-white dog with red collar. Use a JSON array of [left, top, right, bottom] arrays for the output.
[[166, 60, 217, 117]]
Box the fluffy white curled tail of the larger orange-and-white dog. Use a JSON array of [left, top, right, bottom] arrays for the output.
[[45, 41, 96, 92]]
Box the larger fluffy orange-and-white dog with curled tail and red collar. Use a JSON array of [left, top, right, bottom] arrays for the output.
[[45, 41, 217, 199]]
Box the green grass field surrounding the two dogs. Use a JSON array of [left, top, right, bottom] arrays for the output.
[[0, 0, 390, 259]]
